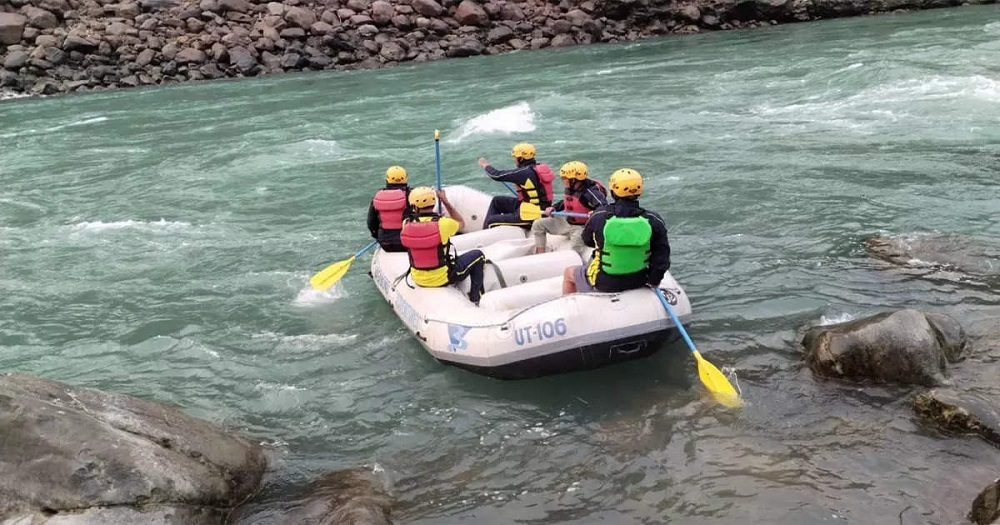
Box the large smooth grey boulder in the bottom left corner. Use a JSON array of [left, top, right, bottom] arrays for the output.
[[0, 374, 265, 525]]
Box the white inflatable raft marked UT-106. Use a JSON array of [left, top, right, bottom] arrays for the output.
[[371, 186, 691, 379]]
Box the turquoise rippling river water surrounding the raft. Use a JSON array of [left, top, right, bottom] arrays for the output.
[[0, 6, 1000, 524]]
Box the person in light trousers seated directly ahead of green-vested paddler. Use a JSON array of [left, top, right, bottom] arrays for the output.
[[531, 160, 608, 254]]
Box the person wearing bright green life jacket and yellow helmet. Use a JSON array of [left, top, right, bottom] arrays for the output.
[[563, 168, 670, 295]]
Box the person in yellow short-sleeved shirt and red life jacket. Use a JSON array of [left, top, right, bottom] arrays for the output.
[[400, 187, 486, 306]]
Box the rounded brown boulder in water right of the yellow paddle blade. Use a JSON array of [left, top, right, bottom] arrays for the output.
[[802, 310, 967, 386]]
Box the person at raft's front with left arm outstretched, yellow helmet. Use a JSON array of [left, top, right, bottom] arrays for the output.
[[479, 142, 556, 229]]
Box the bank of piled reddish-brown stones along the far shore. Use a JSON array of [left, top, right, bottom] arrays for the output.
[[0, 0, 995, 95]]
